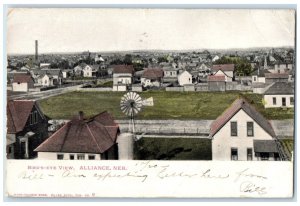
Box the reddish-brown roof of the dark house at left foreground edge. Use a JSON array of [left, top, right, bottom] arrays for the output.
[[6, 100, 37, 134]]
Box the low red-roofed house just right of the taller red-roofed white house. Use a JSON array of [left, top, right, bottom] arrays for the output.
[[141, 68, 164, 87]]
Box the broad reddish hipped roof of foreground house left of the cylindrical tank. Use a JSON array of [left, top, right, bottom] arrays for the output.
[[35, 112, 119, 154]]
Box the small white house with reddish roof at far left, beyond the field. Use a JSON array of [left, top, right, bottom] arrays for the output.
[[12, 73, 34, 92]]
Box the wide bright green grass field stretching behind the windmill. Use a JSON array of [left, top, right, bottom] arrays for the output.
[[40, 91, 294, 119]]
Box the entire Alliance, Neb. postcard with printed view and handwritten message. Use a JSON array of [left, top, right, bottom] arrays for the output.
[[5, 8, 296, 198]]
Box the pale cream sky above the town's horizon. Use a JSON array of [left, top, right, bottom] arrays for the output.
[[7, 8, 295, 54]]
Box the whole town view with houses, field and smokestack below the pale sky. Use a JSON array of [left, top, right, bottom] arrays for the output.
[[6, 40, 295, 161]]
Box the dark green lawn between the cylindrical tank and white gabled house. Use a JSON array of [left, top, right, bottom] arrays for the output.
[[134, 137, 212, 160]]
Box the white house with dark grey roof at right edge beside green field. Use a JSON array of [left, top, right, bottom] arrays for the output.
[[264, 82, 295, 108]]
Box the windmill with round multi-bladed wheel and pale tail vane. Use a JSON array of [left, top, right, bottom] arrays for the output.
[[120, 92, 153, 139]]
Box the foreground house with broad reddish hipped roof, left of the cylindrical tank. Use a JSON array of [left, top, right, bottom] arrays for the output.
[[35, 112, 119, 160]]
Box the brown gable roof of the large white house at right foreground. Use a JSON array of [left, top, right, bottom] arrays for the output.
[[210, 98, 275, 137]]
